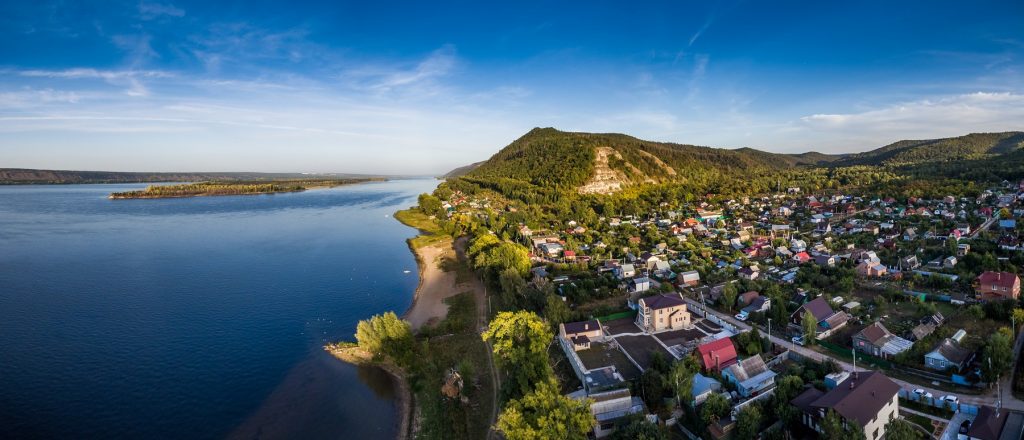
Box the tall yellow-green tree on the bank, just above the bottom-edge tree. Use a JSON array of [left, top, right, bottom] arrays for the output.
[[481, 311, 553, 396]]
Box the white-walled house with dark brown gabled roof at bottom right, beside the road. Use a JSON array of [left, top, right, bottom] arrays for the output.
[[791, 371, 900, 440]]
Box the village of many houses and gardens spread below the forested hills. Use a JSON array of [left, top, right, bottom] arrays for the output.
[[443, 182, 1024, 440]]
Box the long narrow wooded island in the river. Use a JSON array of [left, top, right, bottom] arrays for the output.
[[110, 178, 384, 199]]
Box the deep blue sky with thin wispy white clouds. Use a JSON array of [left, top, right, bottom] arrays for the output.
[[0, 0, 1024, 174]]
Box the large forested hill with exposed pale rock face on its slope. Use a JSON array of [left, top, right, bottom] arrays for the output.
[[458, 128, 842, 193]]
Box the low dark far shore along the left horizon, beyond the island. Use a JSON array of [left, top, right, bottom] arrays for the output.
[[0, 168, 381, 184]]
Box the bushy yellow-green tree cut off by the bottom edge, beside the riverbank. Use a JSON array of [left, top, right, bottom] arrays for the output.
[[497, 378, 597, 440]]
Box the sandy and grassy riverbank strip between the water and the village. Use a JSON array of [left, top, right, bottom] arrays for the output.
[[325, 206, 497, 438]]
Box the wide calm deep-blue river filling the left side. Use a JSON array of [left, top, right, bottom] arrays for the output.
[[0, 179, 437, 439]]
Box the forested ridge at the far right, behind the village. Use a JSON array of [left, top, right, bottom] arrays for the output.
[[836, 131, 1024, 167]]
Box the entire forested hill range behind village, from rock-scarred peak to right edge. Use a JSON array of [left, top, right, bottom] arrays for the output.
[[445, 128, 1024, 194]]
